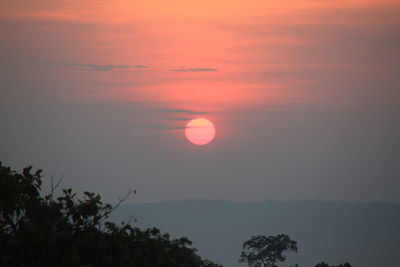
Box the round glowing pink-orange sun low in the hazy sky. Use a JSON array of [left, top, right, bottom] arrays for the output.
[[185, 118, 215, 146]]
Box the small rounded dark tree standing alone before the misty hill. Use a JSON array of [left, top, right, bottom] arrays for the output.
[[239, 234, 297, 267]]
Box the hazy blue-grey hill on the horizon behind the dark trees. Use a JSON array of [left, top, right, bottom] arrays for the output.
[[112, 200, 400, 267]]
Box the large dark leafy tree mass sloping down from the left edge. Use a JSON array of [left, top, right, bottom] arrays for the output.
[[0, 163, 221, 267]]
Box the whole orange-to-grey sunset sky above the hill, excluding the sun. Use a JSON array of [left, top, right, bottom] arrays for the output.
[[0, 0, 400, 203]]
